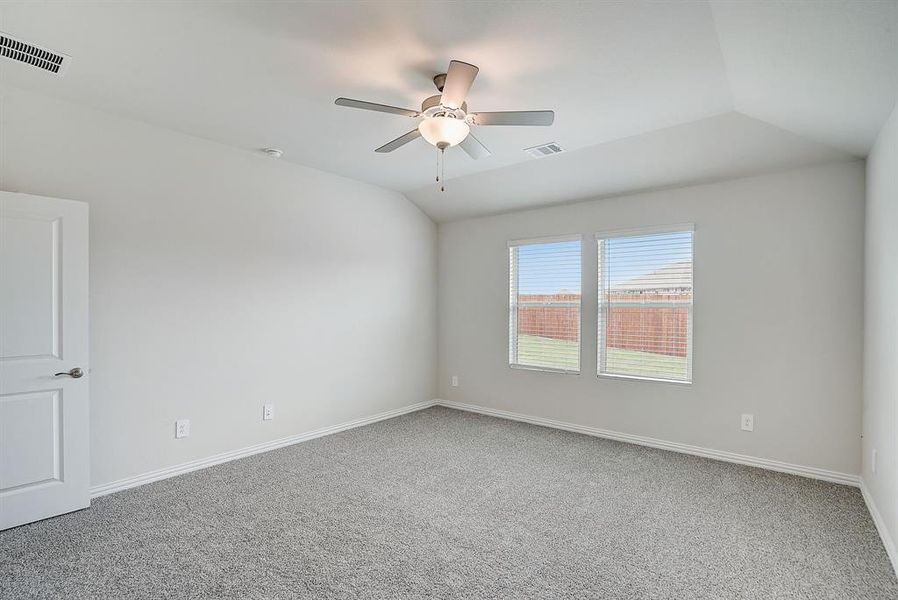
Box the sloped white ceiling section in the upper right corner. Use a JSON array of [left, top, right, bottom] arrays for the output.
[[712, 0, 898, 156]]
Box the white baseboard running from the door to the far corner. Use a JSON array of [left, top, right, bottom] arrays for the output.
[[90, 400, 436, 498]]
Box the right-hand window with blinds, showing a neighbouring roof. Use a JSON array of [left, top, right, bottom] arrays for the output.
[[598, 226, 693, 382]]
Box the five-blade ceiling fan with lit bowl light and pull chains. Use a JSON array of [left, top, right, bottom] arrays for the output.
[[334, 60, 555, 190]]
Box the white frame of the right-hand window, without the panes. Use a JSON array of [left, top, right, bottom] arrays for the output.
[[593, 223, 695, 386]]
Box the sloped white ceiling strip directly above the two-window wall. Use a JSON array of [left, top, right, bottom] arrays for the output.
[[406, 112, 851, 221]]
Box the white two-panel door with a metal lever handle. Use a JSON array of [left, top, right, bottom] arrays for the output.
[[0, 192, 90, 529]]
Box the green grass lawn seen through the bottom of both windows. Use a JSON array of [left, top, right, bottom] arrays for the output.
[[518, 335, 686, 379]]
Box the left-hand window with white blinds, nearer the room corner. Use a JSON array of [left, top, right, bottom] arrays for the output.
[[508, 236, 581, 373]]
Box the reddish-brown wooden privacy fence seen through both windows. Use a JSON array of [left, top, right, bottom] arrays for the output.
[[517, 292, 692, 357]]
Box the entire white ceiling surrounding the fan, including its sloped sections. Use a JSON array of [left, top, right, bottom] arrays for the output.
[[0, 1, 898, 220]]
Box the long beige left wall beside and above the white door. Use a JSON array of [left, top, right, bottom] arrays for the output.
[[0, 90, 436, 485]]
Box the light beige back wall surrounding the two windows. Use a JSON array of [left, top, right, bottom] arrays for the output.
[[438, 162, 864, 474]]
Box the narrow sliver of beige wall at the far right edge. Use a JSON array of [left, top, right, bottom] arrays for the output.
[[863, 102, 898, 556]]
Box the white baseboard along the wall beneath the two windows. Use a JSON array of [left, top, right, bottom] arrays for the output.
[[435, 400, 860, 487]]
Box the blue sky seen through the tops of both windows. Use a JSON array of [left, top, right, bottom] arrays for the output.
[[517, 231, 692, 294]]
